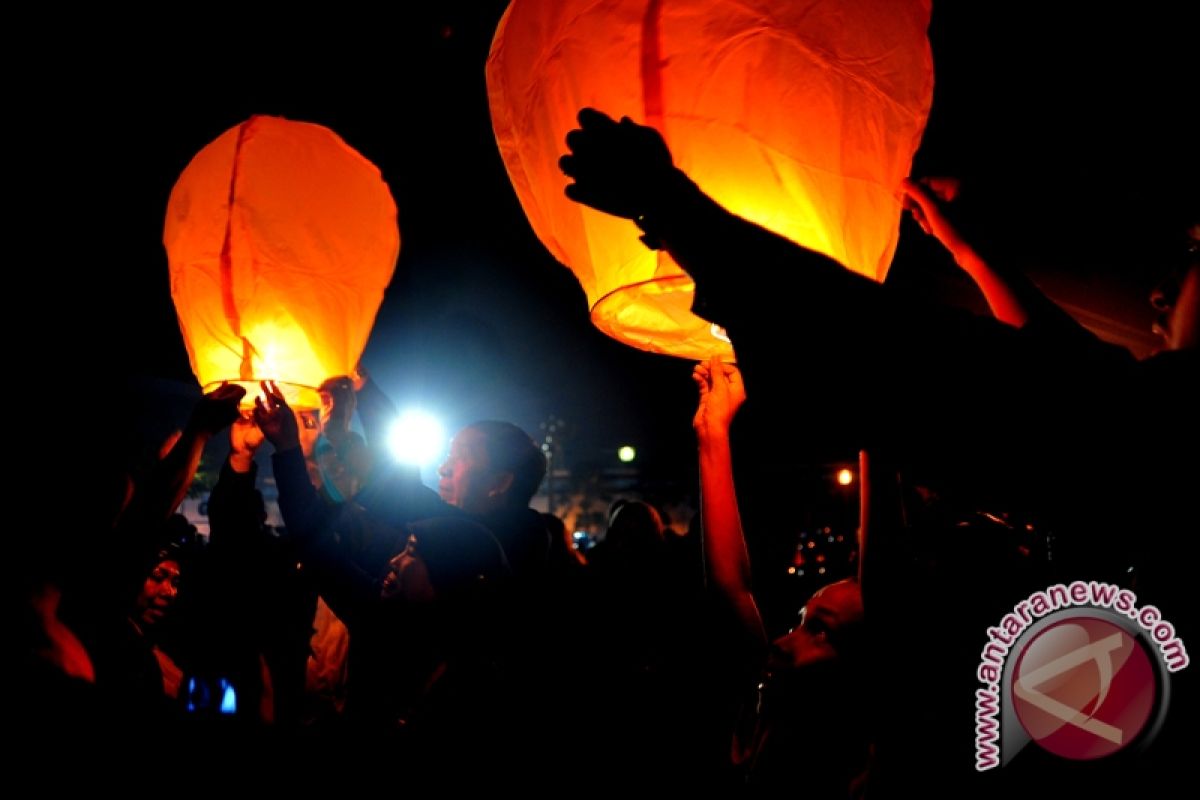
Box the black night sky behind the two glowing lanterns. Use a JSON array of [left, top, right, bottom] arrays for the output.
[[30, 0, 1200, 482]]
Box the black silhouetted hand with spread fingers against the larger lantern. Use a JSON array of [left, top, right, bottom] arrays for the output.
[[558, 108, 678, 219]]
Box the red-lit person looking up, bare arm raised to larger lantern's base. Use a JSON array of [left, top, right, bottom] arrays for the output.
[[692, 357, 868, 798]]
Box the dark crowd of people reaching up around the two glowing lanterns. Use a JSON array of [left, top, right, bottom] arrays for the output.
[[12, 43, 1200, 798]]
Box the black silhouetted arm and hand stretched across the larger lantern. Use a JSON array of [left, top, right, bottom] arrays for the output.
[[559, 109, 1137, 470]]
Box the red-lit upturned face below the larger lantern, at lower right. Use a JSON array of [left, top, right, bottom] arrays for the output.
[[768, 582, 863, 669]]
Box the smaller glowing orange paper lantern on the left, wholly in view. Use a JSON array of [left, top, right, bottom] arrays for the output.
[[163, 116, 400, 408]]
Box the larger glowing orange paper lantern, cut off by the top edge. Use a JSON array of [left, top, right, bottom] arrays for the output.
[[487, 0, 932, 359]]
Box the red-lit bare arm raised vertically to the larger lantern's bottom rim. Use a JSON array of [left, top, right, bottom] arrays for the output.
[[691, 356, 767, 655]]
